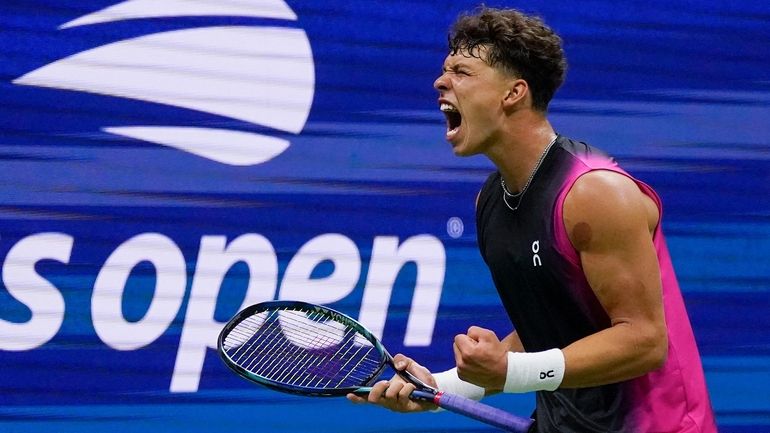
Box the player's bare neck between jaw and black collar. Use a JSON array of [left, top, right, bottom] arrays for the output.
[[486, 112, 556, 193]]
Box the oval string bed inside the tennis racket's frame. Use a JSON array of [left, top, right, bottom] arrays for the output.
[[224, 310, 381, 388]]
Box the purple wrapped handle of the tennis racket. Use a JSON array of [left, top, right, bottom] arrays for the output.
[[433, 392, 533, 433]]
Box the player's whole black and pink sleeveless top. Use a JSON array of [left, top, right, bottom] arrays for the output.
[[476, 136, 716, 433]]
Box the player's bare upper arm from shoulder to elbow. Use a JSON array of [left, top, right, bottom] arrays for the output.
[[564, 172, 662, 325]]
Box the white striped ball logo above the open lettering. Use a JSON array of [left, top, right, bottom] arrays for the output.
[[14, 0, 315, 165]]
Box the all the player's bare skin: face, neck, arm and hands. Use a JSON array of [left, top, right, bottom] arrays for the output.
[[348, 48, 668, 412]]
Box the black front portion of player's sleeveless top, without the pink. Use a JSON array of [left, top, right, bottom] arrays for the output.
[[476, 136, 626, 433]]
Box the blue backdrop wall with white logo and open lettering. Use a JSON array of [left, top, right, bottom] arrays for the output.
[[0, 0, 770, 432]]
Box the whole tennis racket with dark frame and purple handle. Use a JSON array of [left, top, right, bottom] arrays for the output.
[[217, 301, 532, 433]]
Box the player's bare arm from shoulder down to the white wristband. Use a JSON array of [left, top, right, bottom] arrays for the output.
[[562, 171, 668, 388]]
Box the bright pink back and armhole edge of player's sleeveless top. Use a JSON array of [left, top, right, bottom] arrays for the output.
[[554, 157, 717, 433]]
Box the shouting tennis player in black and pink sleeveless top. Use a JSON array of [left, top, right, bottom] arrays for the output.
[[348, 8, 716, 433]]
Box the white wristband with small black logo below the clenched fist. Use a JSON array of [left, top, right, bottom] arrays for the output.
[[503, 349, 564, 392]]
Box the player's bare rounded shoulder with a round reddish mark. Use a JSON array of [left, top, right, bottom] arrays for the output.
[[563, 170, 658, 251]]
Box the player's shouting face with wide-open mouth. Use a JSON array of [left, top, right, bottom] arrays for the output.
[[433, 50, 511, 156]]
